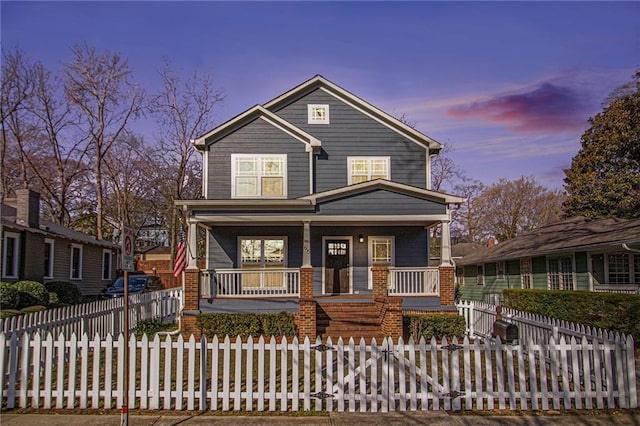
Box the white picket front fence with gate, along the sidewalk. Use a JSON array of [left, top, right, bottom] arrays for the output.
[[0, 333, 638, 412]]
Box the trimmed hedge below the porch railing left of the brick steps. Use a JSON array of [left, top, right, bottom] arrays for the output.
[[196, 312, 296, 338]]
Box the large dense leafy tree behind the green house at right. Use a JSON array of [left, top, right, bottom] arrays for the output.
[[563, 70, 640, 218]]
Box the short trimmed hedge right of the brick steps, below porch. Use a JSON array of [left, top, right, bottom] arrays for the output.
[[403, 313, 467, 340]]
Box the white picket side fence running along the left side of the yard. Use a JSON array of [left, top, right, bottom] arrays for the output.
[[0, 288, 182, 338]]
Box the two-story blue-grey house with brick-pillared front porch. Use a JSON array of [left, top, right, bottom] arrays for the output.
[[176, 75, 463, 337]]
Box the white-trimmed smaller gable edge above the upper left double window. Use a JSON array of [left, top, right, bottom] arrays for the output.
[[192, 105, 321, 150]]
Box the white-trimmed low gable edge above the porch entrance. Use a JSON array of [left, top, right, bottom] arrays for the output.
[[299, 179, 465, 204]]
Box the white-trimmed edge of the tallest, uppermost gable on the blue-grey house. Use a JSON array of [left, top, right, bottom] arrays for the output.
[[264, 74, 442, 153]]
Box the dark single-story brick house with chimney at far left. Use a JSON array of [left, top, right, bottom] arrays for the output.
[[0, 190, 120, 296]]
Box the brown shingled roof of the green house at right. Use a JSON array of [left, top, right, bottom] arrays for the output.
[[457, 217, 640, 265]]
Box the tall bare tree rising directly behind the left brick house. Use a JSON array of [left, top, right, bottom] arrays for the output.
[[64, 44, 144, 238]]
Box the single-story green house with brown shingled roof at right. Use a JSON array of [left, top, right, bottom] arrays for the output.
[[456, 217, 640, 302]]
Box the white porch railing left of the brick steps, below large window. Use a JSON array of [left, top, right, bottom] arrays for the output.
[[200, 268, 300, 298]]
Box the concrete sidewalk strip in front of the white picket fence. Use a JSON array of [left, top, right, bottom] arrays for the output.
[[0, 410, 640, 426]]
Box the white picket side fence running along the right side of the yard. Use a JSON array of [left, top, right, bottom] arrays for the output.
[[456, 301, 627, 344]]
